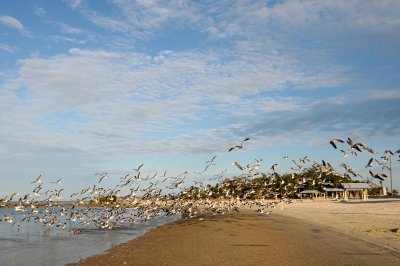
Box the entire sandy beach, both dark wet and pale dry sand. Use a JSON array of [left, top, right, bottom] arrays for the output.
[[69, 200, 400, 265]]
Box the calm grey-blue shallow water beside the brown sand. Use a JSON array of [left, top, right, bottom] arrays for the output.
[[0, 208, 178, 266]]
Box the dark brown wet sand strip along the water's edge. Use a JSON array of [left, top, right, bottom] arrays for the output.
[[72, 202, 400, 265]]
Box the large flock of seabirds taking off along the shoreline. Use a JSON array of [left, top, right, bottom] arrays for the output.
[[0, 138, 400, 235]]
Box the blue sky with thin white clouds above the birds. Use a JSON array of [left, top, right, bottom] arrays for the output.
[[0, 0, 400, 196]]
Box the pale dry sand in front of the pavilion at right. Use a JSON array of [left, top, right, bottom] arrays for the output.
[[276, 198, 400, 251]]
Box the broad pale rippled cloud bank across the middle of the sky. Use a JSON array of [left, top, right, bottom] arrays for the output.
[[3, 41, 395, 161]]
